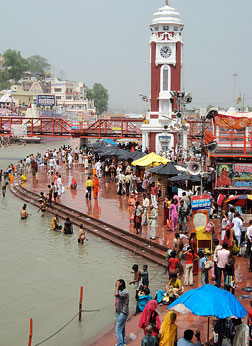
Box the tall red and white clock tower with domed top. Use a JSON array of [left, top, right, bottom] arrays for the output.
[[142, 0, 184, 154]]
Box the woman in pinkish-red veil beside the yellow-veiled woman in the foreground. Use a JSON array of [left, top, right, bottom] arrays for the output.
[[138, 300, 161, 337]]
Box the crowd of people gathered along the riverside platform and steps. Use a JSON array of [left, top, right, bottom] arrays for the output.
[[0, 141, 252, 346]]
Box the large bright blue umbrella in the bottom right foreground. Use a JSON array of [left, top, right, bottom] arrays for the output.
[[168, 284, 247, 318]]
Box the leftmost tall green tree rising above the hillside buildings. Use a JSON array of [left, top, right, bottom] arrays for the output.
[[3, 49, 28, 82]]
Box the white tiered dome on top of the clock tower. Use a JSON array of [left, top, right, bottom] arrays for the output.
[[151, 5, 184, 26]]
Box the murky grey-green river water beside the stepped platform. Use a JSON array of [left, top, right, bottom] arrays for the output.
[[0, 141, 166, 346]]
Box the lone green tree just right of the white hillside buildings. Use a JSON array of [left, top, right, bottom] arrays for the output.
[[87, 83, 109, 115]]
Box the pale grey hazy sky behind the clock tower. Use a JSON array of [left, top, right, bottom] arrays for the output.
[[0, 0, 252, 112]]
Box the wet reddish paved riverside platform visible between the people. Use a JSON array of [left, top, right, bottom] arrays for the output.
[[24, 163, 252, 346]]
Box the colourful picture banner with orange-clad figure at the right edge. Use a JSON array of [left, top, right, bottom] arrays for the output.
[[215, 163, 252, 189]]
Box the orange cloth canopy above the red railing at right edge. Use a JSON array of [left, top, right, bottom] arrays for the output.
[[213, 112, 252, 130]]
